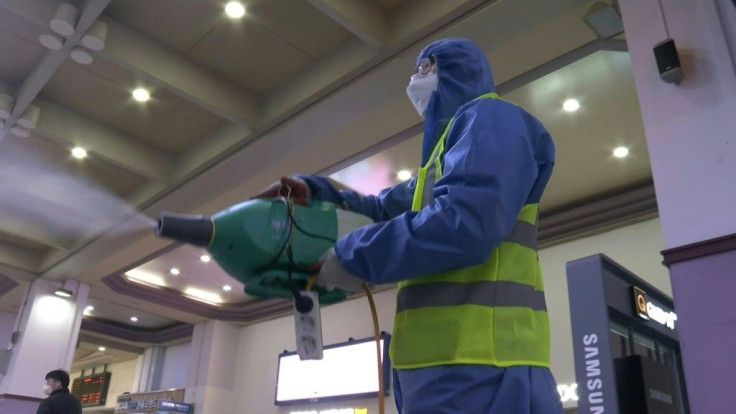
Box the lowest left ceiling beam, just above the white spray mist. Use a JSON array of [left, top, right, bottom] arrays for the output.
[[33, 98, 174, 183]]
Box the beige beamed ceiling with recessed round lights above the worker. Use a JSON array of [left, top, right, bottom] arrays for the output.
[[0, 0, 651, 362]]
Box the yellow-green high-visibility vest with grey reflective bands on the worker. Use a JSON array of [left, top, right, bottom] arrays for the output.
[[390, 93, 549, 369]]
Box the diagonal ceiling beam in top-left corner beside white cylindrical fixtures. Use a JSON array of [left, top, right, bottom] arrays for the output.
[[0, 0, 111, 139]]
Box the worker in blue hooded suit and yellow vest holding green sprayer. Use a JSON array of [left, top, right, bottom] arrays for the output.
[[257, 39, 562, 414]]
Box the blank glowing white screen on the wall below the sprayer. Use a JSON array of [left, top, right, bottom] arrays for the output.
[[275, 333, 391, 405]]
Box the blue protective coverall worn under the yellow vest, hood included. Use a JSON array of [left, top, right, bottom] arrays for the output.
[[300, 39, 562, 414]]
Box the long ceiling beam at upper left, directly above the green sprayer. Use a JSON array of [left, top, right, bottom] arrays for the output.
[[97, 18, 260, 129]]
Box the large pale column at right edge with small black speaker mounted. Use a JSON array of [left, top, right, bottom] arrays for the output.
[[621, 0, 736, 414]]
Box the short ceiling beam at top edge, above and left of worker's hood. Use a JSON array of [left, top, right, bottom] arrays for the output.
[[307, 0, 389, 47]]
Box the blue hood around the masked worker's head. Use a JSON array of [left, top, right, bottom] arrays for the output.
[[417, 39, 494, 165]]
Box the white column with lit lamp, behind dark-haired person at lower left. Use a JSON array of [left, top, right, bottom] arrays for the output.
[[0, 279, 89, 414]]
